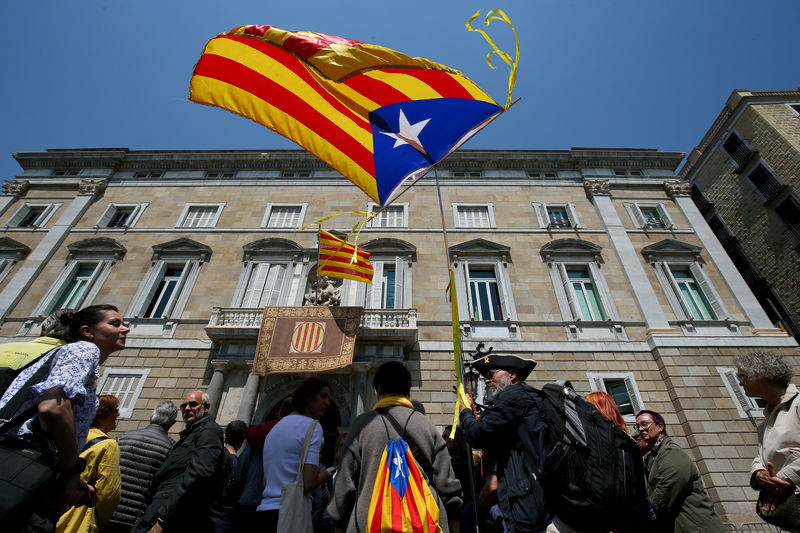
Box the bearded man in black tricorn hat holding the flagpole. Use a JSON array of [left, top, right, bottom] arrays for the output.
[[460, 353, 550, 533]]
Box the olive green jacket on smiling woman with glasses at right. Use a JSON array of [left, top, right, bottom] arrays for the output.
[[645, 437, 723, 533]]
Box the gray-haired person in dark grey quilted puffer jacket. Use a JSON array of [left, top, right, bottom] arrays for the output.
[[104, 401, 178, 533]]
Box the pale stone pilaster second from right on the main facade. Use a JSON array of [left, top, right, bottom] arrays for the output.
[[583, 179, 677, 335]]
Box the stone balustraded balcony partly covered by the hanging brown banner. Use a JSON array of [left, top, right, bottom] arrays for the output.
[[206, 307, 418, 346]]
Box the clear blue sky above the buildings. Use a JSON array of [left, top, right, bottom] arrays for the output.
[[0, 0, 800, 180]]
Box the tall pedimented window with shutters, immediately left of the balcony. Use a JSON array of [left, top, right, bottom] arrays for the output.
[[130, 239, 211, 322]]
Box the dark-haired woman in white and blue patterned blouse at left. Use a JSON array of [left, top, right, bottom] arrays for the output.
[[0, 304, 130, 524]]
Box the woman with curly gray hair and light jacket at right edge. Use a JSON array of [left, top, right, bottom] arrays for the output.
[[735, 352, 800, 531]]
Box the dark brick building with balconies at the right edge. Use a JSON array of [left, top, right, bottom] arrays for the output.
[[680, 89, 800, 338]]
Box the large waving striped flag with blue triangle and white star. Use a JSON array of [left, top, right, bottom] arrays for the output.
[[189, 26, 503, 205]]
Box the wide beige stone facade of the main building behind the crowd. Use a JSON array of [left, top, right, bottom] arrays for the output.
[[0, 148, 797, 522]]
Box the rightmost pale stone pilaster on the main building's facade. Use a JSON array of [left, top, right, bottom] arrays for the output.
[[664, 181, 784, 335]]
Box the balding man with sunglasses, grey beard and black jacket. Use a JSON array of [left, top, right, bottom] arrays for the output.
[[131, 391, 228, 533]]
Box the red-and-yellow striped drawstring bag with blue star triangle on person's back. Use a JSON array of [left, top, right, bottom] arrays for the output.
[[367, 438, 439, 533]]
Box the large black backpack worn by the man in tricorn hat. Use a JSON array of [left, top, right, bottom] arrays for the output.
[[518, 382, 652, 532]]
